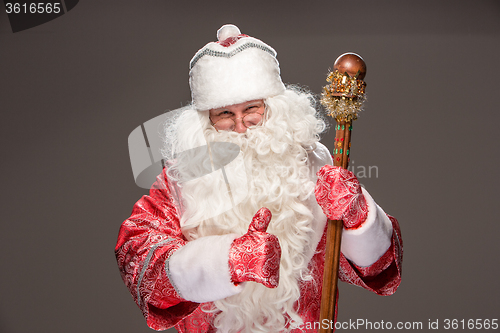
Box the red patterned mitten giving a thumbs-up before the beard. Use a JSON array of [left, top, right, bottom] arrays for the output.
[[229, 208, 281, 288]]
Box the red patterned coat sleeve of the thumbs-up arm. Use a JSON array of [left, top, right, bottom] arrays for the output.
[[115, 171, 198, 330]]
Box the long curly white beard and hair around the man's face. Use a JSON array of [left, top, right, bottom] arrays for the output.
[[165, 90, 325, 332]]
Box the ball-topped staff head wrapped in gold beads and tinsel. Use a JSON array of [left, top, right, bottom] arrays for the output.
[[321, 52, 366, 122]]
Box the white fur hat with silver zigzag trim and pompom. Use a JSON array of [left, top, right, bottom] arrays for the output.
[[189, 24, 285, 111]]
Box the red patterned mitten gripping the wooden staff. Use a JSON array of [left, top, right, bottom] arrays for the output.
[[314, 165, 368, 229]]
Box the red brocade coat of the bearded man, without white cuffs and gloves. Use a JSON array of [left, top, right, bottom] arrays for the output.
[[115, 167, 403, 333]]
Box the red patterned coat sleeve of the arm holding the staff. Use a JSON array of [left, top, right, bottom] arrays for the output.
[[339, 216, 403, 296]]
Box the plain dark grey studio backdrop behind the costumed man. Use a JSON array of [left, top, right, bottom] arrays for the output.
[[0, 0, 500, 333]]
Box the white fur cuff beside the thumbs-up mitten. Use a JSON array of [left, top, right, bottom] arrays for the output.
[[169, 234, 243, 303]]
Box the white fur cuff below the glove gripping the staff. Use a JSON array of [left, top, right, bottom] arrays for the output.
[[340, 188, 392, 267]]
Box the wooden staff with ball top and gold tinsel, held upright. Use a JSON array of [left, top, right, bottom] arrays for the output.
[[319, 53, 366, 333]]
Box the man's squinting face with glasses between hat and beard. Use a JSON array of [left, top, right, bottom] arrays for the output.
[[210, 99, 266, 133]]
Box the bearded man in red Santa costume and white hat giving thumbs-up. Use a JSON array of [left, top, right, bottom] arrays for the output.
[[116, 25, 402, 332]]
